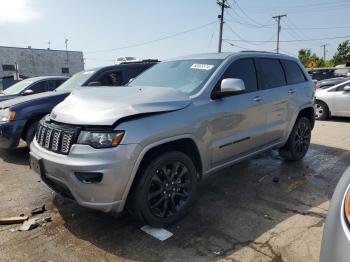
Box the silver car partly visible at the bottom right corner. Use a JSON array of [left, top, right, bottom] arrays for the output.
[[320, 168, 350, 262]]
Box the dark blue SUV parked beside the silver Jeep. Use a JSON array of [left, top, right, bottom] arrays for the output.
[[0, 61, 156, 148]]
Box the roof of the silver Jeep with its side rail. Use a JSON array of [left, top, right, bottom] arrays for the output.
[[174, 51, 291, 60]]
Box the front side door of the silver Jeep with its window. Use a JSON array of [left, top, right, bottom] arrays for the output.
[[205, 58, 266, 167]]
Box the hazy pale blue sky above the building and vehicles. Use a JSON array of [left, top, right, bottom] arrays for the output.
[[0, 0, 350, 68]]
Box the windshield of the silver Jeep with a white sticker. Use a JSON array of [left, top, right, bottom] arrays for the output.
[[129, 59, 222, 95]]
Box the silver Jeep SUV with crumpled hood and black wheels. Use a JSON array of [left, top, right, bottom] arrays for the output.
[[30, 52, 314, 226]]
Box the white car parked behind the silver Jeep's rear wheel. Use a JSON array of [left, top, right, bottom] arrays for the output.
[[315, 80, 350, 120]]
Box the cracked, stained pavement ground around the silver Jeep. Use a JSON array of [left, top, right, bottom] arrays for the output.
[[0, 119, 350, 262]]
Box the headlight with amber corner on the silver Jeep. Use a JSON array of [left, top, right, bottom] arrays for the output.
[[78, 131, 124, 148]]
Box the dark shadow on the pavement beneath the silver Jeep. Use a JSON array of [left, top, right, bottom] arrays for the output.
[[54, 145, 350, 261]]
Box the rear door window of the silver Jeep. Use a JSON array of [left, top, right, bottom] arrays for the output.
[[257, 58, 286, 89]]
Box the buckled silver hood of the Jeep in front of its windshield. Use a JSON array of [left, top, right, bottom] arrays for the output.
[[50, 86, 191, 126]]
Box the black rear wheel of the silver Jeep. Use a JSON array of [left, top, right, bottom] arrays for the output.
[[279, 117, 312, 161]]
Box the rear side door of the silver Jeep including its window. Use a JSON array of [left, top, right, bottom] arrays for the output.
[[256, 58, 293, 145]]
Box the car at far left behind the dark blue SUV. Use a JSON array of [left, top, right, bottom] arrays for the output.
[[0, 76, 68, 102]]
